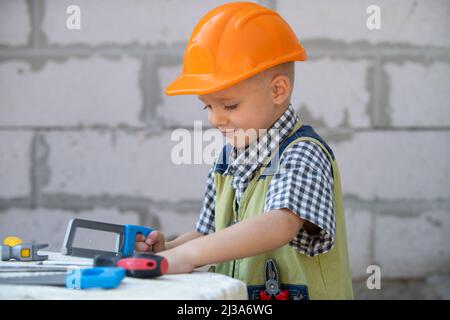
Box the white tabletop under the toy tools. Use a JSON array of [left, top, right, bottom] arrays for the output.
[[0, 251, 247, 300]]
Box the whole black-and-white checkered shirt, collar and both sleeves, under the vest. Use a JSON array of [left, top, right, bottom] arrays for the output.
[[196, 105, 336, 256]]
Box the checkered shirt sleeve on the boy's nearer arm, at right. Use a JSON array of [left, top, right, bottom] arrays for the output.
[[264, 141, 336, 256]]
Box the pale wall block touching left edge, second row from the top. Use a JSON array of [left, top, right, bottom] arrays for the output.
[[0, 56, 142, 127]]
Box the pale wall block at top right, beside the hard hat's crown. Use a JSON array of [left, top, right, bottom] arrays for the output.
[[276, 0, 450, 48]]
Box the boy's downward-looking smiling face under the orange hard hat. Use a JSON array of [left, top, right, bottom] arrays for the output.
[[198, 79, 280, 148]]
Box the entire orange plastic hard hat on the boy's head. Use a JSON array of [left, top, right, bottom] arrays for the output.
[[165, 2, 306, 95]]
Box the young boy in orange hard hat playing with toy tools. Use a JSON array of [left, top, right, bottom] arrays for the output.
[[136, 2, 353, 299]]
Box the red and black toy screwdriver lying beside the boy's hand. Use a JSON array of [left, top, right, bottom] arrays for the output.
[[94, 254, 169, 279]]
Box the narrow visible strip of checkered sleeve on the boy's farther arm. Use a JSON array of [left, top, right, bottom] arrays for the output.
[[196, 165, 216, 235]]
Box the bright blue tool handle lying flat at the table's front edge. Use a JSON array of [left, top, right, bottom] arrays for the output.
[[66, 267, 125, 289]]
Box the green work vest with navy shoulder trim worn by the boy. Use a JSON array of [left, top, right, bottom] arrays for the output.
[[212, 121, 353, 299]]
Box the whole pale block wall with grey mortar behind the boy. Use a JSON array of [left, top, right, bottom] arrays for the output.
[[0, 0, 450, 290]]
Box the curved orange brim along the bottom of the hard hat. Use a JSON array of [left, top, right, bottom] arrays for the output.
[[165, 50, 306, 96]]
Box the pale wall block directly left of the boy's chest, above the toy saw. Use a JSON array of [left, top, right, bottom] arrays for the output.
[[43, 132, 208, 201]]
